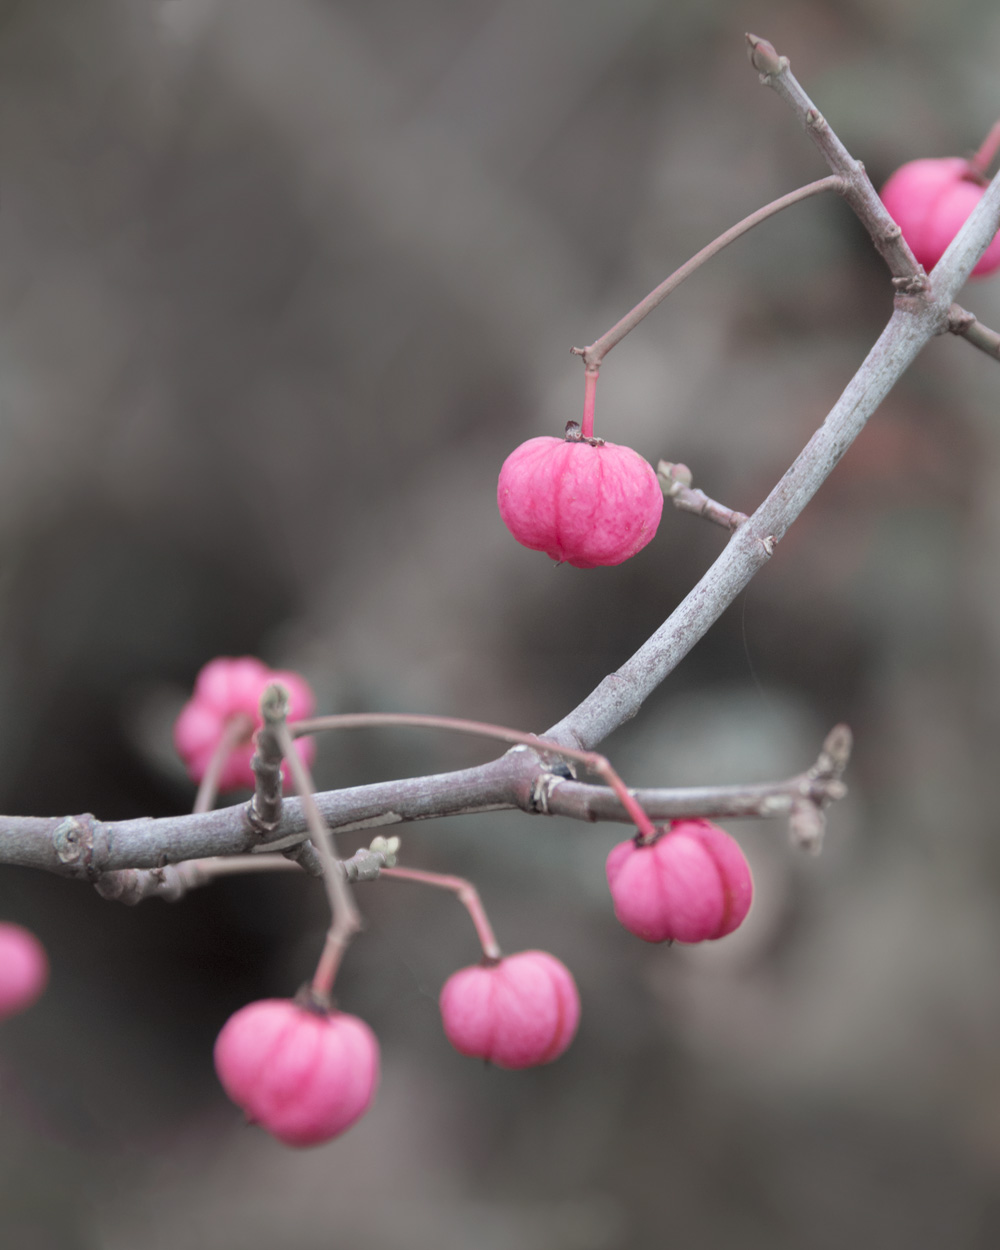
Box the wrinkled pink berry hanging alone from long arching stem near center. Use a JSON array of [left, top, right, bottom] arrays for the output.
[[496, 436, 664, 569]]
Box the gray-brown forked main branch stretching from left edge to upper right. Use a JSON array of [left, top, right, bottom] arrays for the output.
[[0, 40, 1000, 880]]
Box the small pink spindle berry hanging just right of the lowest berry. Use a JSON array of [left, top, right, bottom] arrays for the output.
[[440, 950, 580, 1068]]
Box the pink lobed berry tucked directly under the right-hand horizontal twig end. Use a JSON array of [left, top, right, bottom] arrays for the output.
[[606, 820, 754, 943]]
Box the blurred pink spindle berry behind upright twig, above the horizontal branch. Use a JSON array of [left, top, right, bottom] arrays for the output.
[[174, 655, 316, 791]]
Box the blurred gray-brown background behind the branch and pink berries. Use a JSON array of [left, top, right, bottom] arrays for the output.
[[0, 0, 1000, 1250]]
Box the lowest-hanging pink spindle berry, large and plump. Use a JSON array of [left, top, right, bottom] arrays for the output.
[[215, 999, 379, 1146]]
